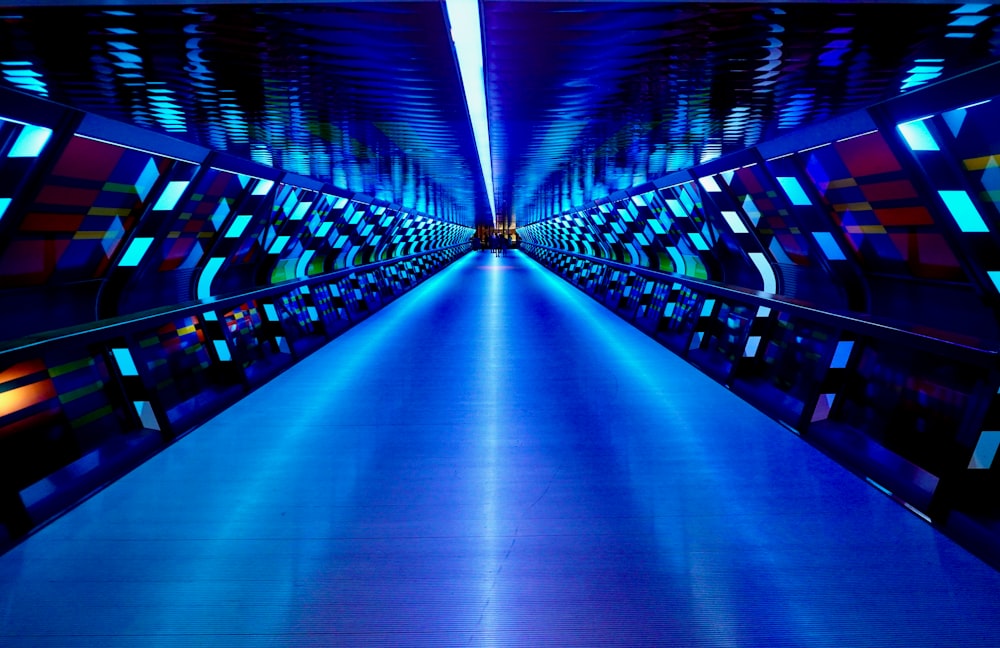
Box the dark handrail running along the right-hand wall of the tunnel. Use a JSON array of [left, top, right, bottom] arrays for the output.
[[521, 241, 1000, 366]]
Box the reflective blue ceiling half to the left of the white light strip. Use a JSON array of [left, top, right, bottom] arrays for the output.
[[0, 2, 489, 224]]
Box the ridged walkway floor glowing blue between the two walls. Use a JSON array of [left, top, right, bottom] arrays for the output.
[[0, 253, 1000, 648]]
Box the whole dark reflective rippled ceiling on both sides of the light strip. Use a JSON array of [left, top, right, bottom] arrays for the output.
[[0, 0, 1000, 230]]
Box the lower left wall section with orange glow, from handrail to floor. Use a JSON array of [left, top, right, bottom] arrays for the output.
[[0, 243, 470, 549]]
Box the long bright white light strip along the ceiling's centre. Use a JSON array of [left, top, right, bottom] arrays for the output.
[[445, 0, 496, 222]]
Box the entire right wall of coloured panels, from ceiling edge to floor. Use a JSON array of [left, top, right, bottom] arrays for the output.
[[518, 60, 1000, 565]]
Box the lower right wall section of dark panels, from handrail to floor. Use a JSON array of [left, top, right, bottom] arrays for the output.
[[522, 242, 1000, 568]]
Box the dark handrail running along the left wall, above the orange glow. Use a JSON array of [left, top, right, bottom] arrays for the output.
[[0, 242, 469, 361]]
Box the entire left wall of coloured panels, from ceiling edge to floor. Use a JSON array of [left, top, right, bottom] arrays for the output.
[[0, 89, 472, 547]]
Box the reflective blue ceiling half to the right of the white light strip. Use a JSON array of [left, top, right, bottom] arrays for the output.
[[486, 2, 998, 225]]
